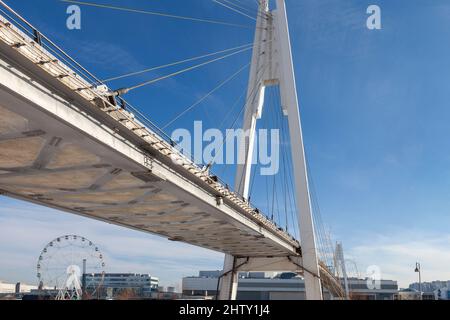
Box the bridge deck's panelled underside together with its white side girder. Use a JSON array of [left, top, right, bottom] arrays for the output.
[[0, 52, 296, 256]]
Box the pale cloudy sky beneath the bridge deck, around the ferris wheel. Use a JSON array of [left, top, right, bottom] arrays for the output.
[[0, 199, 223, 286]]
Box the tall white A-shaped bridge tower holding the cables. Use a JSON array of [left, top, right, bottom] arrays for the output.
[[219, 0, 322, 300]]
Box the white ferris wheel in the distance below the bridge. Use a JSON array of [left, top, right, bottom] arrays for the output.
[[37, 235, 105, 300]]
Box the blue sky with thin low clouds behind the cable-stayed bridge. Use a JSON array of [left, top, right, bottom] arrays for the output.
[[0, 0, 450, 286]]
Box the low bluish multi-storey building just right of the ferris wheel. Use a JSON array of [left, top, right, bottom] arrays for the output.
[[86, 273, 159, 299]]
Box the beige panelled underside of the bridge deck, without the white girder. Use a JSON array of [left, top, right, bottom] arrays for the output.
[[0, 102, 294, 256]]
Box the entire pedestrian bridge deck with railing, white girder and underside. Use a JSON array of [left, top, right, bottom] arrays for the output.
[[0, 6, 343, 296]]
